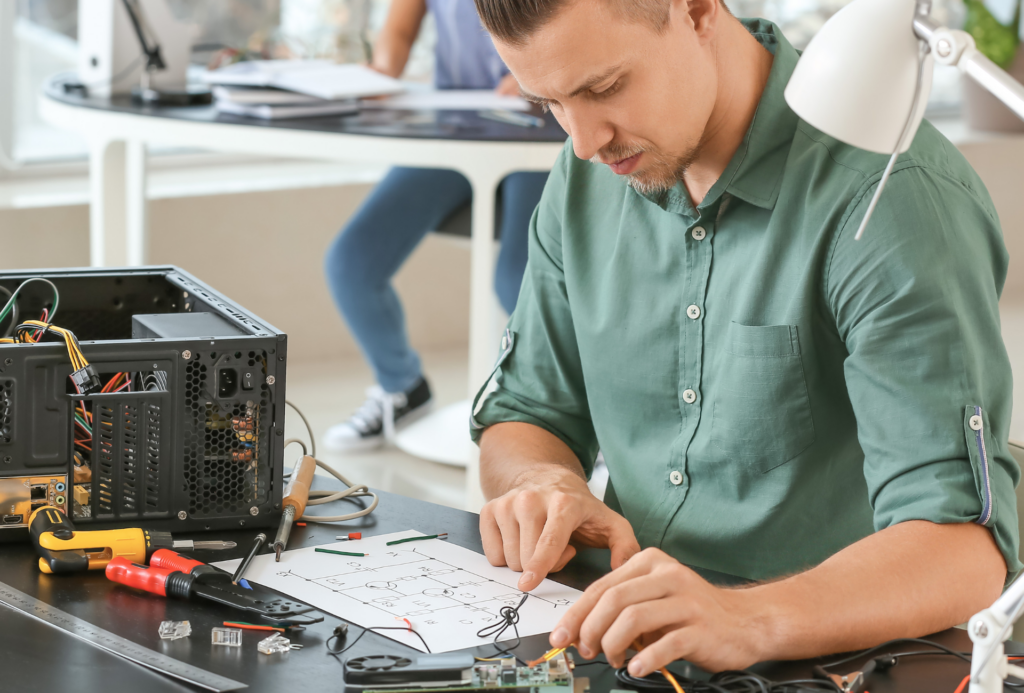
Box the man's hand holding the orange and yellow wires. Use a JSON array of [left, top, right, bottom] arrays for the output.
[[551, 549, 764, 677]]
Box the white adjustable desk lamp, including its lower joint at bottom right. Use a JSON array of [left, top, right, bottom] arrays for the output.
[[785, 0, 1024, 693]]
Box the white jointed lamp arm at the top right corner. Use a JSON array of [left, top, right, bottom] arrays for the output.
[[913, 14, 1024, 120]]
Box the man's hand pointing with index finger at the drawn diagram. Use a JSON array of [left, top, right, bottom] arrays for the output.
[[480, 469, 640, 592]]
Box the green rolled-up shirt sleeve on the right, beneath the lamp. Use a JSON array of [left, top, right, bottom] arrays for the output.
[[825, 159, 1021, 576]]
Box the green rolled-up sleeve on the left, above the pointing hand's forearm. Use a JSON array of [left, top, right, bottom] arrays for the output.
[[470, 145, 597, 476]]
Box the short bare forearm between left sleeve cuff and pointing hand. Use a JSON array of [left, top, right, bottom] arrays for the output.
[[480, 422, 587, 501]]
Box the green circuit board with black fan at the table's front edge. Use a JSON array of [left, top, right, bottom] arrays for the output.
[[345, 652, 590, 693]]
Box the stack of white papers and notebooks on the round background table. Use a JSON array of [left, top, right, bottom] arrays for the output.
[[203, 60, 403, 119]]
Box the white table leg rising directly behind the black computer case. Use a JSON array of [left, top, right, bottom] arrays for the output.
[[89, 140, 127, 267]]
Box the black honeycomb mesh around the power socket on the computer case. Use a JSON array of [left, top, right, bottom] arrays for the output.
[[183, 351, 270, 517]]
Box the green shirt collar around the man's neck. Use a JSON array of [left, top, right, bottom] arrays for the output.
[[645, 19, 800, 212]]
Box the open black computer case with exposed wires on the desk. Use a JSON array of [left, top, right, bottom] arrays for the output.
[[0, 266, 288, 542]]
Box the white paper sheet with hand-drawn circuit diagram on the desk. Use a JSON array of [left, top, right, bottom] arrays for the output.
[[211, 531, 581, 652]]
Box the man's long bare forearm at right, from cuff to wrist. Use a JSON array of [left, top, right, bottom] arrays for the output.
[[737, 521, 1007, 659]]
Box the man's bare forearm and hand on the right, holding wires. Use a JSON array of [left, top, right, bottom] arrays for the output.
[[551, 520, 1007, 677]]
